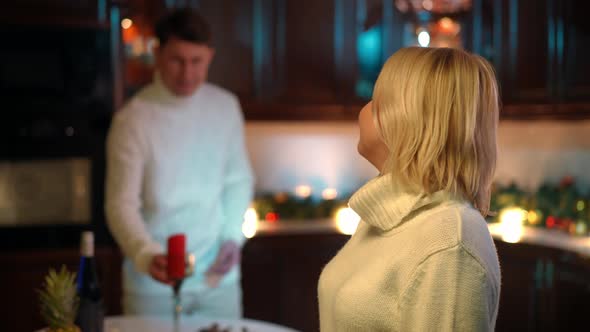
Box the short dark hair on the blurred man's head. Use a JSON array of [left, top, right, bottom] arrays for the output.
[[155, 8, 211, 46]]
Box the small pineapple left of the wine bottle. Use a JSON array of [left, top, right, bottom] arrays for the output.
[[39, 266, 80, 332]]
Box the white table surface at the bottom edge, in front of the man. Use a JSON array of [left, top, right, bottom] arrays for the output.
[[104, 315, 295, 332]]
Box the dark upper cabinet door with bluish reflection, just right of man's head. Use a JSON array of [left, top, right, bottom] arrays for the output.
[[198, 0, 352, 104]]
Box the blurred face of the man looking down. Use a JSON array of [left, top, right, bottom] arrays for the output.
[[156, 37, 215, 97]]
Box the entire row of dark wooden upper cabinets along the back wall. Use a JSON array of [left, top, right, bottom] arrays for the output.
[[0, 0, 590, 121]]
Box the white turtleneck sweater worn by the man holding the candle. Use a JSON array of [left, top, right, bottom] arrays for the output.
[[106, 77, 253, 294]]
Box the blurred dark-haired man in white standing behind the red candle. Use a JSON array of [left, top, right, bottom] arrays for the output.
[[105, 9, 253, 317]]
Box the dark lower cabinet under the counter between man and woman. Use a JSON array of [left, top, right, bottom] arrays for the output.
[[242, 234, 349, 331]]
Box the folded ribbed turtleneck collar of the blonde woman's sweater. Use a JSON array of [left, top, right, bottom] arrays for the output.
[[349, 174, 452, 231]]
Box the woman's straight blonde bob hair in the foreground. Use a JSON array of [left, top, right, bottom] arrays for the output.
[[373, 47, 500, 216]]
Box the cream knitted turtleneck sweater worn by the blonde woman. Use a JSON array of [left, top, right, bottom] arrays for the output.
[[318, 176, 500, 332]]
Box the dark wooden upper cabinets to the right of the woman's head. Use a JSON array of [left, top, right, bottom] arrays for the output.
[[478, 0, 590, 119]]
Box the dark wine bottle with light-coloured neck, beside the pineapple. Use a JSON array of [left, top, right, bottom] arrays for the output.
[[76, 231, 104, 332]]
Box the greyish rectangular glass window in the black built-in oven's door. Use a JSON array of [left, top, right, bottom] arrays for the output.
[[0, 158, 92, 227]]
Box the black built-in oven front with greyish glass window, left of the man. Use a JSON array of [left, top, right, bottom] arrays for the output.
[[0, 112, 112, 249]]
